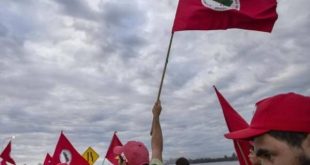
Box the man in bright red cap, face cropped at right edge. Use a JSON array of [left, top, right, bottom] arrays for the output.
[[225, 93, 310, 165]]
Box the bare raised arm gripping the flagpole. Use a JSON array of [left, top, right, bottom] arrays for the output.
[[151, 100, 163, 161]]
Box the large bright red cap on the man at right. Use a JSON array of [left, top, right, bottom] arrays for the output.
[[225, 93, 310, 139]]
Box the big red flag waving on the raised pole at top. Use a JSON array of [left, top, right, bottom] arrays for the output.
[[172, 0, 278, 32]]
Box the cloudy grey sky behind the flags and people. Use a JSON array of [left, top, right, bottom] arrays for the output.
[[0, 0, 310, 165]]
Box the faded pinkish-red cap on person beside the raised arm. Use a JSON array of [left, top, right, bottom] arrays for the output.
[[113, 141, 149, 165]]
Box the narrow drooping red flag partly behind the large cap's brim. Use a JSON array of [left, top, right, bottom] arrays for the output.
[[214, 86, 251, 165]]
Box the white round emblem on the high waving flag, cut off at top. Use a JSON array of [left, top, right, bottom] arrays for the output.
[[201, 0, 240, 11]]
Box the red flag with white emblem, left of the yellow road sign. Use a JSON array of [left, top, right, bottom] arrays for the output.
[[52, 132, 89, 165]]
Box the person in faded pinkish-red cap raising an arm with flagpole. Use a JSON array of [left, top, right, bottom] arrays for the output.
[[113, 101, 163, 165]]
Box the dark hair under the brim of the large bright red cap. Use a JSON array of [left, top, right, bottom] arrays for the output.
[[268, 131, 308, 147]]
